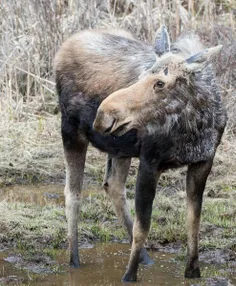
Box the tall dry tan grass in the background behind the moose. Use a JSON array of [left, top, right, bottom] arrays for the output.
[[0, 0, 236, 188]]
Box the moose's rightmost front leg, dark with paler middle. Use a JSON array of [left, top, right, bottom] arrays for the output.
[[185, 160, 212, 278]]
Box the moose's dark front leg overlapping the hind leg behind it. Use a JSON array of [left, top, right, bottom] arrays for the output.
[[122, 160, 158, 282]]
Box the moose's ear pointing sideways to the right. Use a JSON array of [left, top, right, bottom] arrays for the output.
[[185, 45, 223, 72]]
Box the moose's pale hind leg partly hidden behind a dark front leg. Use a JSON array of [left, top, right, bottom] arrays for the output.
[[103, 155, 153, 265]]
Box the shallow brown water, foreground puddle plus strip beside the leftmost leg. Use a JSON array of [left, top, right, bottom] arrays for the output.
[[0, 185, 236, 286]]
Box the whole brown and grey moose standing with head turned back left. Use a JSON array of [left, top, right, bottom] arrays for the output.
[[54, 26, 227, 282]]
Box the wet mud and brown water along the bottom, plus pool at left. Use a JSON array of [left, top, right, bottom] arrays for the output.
[[0, 185, 236, 286]]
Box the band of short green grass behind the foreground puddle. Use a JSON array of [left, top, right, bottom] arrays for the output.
[[0, 185, 236, 255]]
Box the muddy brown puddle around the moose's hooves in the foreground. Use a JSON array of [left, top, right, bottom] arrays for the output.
[[0, 243, 236, 286]]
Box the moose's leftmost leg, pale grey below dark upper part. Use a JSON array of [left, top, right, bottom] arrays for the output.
[[62, 122, 88, 268]]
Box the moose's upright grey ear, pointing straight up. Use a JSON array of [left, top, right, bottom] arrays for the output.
[[154, 25, 170, 56]]
